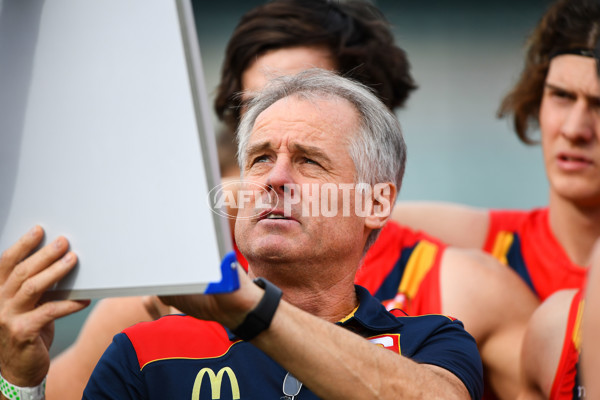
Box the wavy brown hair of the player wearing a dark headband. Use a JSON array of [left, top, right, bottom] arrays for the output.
[[498, 0, 600, 144]]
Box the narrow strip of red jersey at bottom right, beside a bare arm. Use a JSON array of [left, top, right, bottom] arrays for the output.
[[550, 290, 585, 400]]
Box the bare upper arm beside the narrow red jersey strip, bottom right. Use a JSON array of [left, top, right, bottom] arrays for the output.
[[518, 290, 576, 400]]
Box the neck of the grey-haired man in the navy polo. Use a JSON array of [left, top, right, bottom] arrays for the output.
[[248, 263, 358, 322]]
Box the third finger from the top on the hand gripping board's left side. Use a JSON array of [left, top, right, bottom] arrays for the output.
[[7, 251, 77, 309]]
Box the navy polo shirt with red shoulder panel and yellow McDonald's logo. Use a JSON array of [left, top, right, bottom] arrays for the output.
[[83, 286, 483, 400]]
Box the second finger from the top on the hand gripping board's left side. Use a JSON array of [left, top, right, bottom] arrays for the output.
[[4, 236, 75, 296]]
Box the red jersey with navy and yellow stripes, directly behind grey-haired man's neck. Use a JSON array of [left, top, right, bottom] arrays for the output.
[[355, 221, 446, 315]]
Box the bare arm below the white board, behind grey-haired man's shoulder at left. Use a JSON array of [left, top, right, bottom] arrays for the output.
[[46, 297, 154, 400]]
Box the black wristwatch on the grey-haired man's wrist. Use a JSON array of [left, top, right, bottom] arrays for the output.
[[232, 278, 283, 341]]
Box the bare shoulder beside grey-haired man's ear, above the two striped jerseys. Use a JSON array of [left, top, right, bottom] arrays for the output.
[[392, 201, 489, 249]]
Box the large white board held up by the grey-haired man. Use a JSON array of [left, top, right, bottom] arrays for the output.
[[0, 0, 234, 298]]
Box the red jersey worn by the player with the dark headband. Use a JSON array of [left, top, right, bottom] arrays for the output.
[[484, 208, 587, 301]]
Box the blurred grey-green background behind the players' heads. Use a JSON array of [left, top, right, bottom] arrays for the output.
[[51, 0, 550, 355]]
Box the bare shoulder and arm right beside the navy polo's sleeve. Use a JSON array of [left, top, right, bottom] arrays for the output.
[[440, 247, 539, 399]]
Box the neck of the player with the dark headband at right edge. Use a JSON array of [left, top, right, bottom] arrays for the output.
[[549, 194, 600, 266]]
